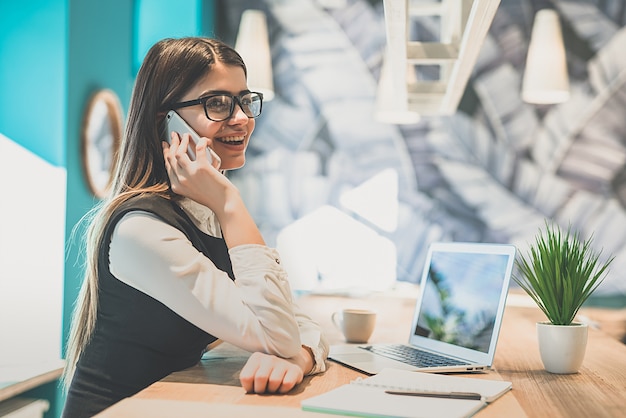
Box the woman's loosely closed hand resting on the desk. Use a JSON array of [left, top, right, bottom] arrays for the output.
[[239, 347, 313, 393]]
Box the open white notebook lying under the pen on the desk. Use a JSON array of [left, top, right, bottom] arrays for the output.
[[301, 369, 512, 418]]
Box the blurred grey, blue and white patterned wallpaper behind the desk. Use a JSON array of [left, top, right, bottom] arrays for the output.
[[218, 0, 626, 295]]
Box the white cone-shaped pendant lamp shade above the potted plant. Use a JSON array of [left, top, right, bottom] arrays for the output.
[[522, 9, 570, 104]]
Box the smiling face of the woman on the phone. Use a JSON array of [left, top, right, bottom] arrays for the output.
[[177, 62, 255, 170]]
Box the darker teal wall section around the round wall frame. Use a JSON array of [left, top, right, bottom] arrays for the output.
[[63, 0, 133, 356]]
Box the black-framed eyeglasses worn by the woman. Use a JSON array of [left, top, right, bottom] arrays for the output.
[[171, 91, 263, 122]]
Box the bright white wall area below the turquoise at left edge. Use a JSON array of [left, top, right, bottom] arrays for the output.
[[0, 134, 66, 366]]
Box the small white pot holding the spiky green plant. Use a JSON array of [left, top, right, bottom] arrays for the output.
[[537, 322, 587, 374]]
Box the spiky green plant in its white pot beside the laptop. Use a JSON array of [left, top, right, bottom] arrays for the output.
[[513, 221, 613, 374]]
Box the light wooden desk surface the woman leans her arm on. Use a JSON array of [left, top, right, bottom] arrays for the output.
[[97, 295, 626, 418]]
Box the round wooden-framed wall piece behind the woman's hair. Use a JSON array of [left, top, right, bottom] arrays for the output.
[[81, 89, 123, 198]]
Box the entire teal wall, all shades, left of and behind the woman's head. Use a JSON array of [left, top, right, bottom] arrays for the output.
[[0, 0, 215, 418]]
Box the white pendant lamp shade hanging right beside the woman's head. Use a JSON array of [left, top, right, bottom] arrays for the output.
[[235, 9, 274, 101]]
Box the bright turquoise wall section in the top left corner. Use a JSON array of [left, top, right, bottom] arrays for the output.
[[0, 0, 68, 166]]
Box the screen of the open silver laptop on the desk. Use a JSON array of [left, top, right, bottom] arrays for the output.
[[413, 244, 513, 353]]
